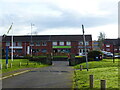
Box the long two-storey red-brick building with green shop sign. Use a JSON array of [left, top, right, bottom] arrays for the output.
[[2, 35, 92, 56]]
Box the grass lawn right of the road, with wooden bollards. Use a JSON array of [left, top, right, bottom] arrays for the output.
[[73, 59, 120, 90]]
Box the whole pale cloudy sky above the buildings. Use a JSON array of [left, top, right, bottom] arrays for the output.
[[0, 0, 119, 40]]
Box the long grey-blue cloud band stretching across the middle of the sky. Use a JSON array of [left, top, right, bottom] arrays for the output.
[[0, 0, 117, 31]]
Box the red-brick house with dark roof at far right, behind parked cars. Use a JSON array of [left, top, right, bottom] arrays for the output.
[[103, 39, 120, 53]]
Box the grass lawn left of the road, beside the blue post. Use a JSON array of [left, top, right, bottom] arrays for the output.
[[2, 59, 48, 73]]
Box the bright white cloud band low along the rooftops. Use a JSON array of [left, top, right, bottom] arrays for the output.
[[39, 24, 118, 40]]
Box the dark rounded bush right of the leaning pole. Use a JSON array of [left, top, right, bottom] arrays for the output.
[[88, 50, 103, 61]]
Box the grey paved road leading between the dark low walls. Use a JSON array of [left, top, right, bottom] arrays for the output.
[[2, 61, 74, 88]]
